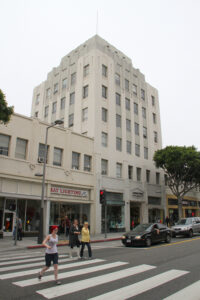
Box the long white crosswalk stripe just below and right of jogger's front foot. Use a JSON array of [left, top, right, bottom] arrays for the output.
[[37, 265, 156, 299]]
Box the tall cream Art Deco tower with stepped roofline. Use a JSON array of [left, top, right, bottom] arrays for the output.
[[31, 35, 166, 232]]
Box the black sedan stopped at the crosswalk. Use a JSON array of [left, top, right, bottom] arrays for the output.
[[122, 223, 171, 247]]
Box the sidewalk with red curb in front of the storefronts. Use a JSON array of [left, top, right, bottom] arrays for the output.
[[0, 232, 123, 253]]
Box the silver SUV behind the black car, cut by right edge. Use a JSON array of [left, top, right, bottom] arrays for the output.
[[171, 217, 200, 237]]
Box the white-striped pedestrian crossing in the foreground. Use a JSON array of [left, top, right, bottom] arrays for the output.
[[0, 253, 200, 300]]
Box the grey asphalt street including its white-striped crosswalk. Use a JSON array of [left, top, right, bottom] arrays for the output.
[[0, 236, 200, 300]]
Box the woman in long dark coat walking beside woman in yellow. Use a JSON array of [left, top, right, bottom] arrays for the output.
[[69, 219, 80, 258]]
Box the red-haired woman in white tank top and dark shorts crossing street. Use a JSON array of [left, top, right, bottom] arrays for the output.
[[38, 225, 61, 285]]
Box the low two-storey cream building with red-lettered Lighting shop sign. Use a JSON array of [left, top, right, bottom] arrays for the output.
[[0, 114, 96, 236]]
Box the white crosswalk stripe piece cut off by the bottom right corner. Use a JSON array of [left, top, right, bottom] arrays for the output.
[[163, 280, 200, 300]]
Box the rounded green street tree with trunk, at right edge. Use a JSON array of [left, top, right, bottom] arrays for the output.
[[153, 146, 200, 218]]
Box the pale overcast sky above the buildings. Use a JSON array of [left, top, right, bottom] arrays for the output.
[[0, 0, 200, 149]]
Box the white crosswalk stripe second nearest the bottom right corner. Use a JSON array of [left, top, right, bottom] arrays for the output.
[[89, 270, 189, 300]]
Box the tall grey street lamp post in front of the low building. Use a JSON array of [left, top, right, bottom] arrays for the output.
[[38, 120, 64, 244]]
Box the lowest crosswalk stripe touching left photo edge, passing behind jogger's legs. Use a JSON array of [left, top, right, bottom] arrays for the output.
[[0, 258, 105, 280]]
